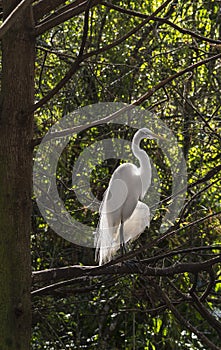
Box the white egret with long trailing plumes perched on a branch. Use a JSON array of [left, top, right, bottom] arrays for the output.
[[95, 128, 159, 265]]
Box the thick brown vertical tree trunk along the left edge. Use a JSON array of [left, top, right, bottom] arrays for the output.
[[0, 0, 34, 350]]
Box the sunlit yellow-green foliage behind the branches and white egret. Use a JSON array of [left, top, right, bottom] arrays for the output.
[[32, 0, 221, 350]]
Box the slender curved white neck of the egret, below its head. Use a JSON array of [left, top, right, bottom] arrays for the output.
[[132, 134, 151, 198]]
